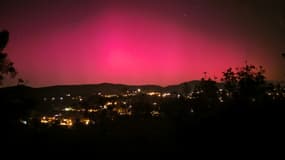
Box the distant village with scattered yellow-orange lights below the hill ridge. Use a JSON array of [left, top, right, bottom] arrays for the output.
[[19, 84, 285, 128]]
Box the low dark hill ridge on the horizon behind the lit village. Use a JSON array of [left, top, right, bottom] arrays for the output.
[[0, 81, 214, 97]]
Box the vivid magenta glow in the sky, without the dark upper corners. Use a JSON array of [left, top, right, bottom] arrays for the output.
[[0, 0, 282, 86]]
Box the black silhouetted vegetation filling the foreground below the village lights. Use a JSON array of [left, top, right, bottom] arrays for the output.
[[1, 65, 285, 153]]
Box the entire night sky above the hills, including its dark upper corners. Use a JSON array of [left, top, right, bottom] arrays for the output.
[[0, 0, 285, 87]]
